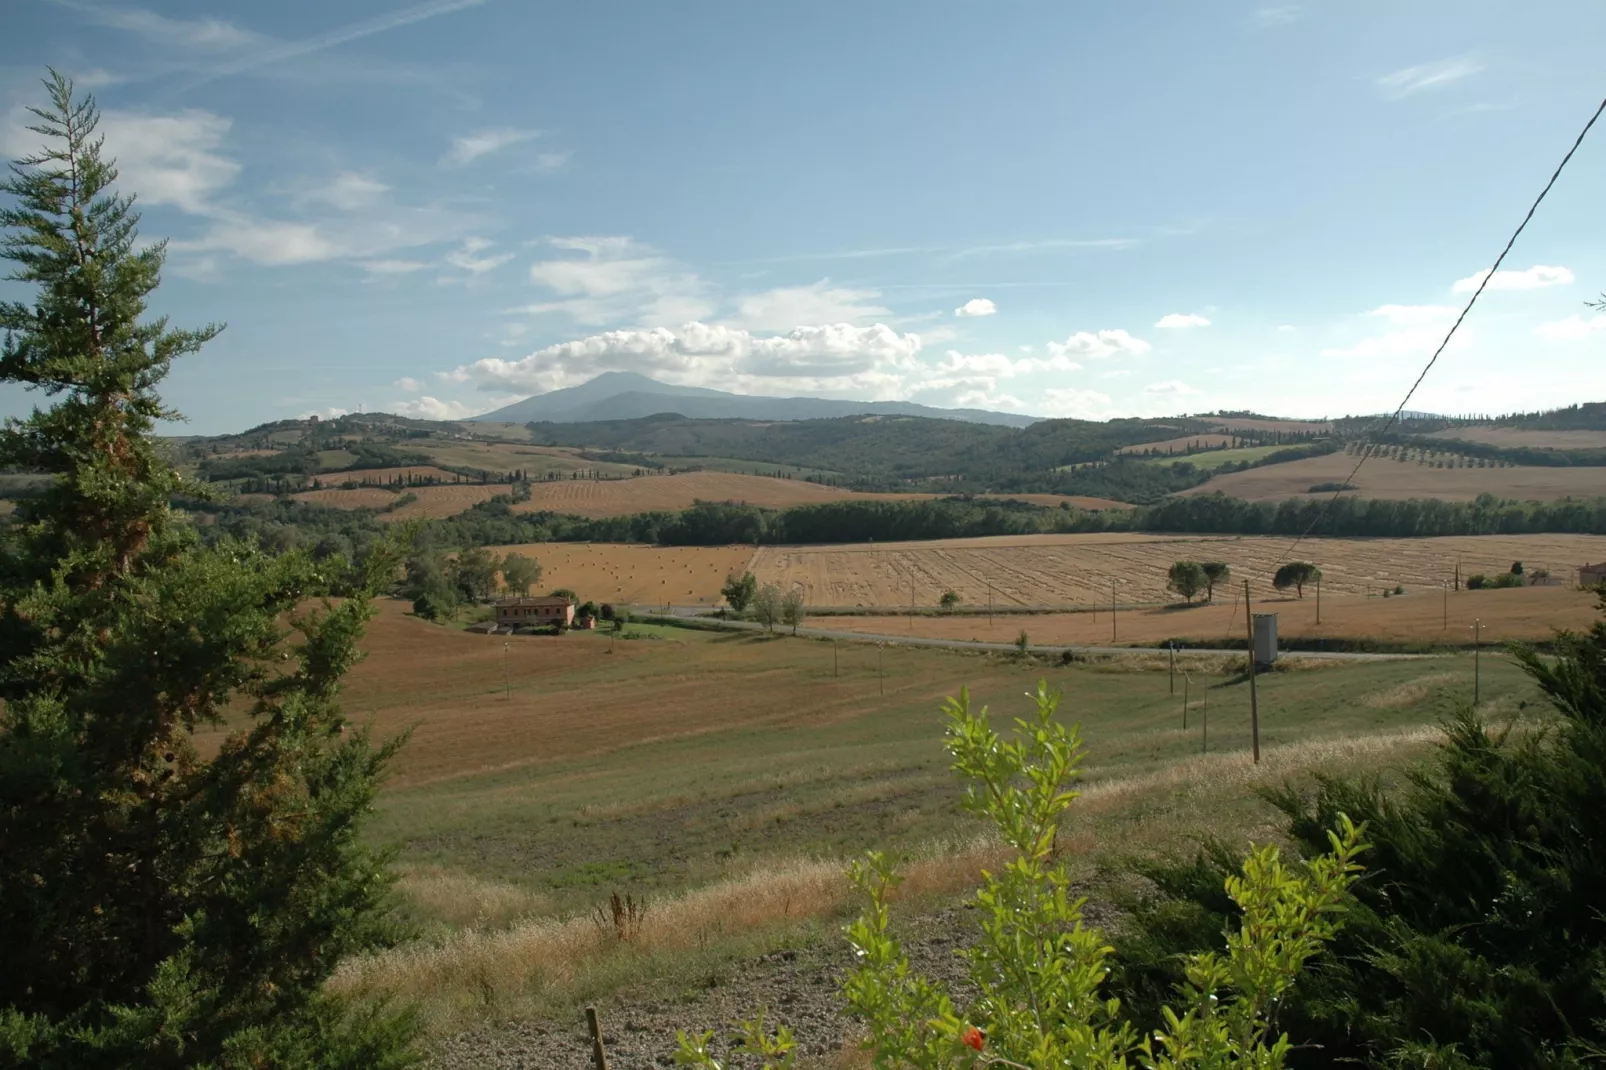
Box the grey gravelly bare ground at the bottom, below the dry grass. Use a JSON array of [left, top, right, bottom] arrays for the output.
[[430, 908, 975, 1070]]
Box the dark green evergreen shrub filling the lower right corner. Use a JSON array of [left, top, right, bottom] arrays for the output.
[[1116, 594, 1606, 1068]]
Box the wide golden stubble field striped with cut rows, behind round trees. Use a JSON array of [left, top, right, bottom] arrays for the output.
[[753, 533, 1606, 607]]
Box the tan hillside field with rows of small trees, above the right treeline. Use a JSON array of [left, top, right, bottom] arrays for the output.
[[1182, 453, 1606, 501]]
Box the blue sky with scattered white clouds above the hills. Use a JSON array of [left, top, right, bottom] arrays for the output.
[[0, 0, 1606, 432]]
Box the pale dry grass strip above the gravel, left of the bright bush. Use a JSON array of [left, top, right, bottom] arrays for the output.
[[329, 840, 1005, 1027]]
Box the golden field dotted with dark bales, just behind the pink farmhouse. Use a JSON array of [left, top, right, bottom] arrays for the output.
[[491, 543, 753, 606]]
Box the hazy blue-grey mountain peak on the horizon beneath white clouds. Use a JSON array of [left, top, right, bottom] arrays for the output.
[[474, 371, 1037, 427]]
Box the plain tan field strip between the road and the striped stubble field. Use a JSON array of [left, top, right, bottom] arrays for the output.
[[809, 586, 1600, 646]]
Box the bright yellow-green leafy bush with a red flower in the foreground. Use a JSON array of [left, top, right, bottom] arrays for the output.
[[676, 681, 1362, 1070]]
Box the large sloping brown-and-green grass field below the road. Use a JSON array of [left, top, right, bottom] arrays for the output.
[[309, 602, 1532, 1030]]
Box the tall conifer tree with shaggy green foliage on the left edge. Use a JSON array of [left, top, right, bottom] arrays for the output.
[[0, 72, 411, 1068]]
